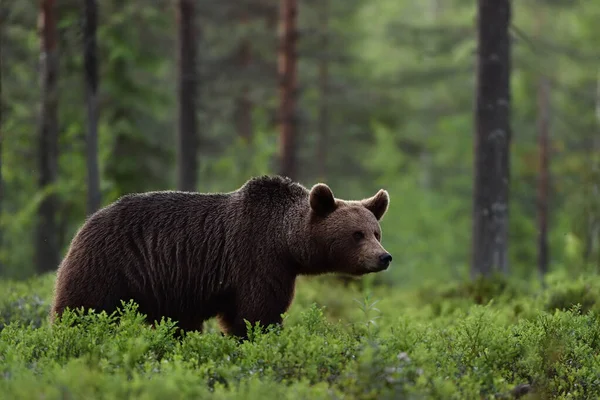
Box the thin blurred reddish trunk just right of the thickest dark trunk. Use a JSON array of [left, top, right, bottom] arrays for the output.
[[537, 76, 550, 277]]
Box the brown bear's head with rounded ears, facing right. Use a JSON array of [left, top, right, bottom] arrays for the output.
[[309, 183, 392, 276]]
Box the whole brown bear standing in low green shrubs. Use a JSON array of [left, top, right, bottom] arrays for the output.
[[50, 176, 392, 338]]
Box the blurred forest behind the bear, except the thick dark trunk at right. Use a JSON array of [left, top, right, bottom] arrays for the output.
[[0, 0, 600, 287]]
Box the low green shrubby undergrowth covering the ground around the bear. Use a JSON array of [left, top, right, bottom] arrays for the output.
[[0, 274, 600, 399]]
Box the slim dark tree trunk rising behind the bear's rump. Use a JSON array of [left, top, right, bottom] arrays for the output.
[[83, 0, 101, 215]]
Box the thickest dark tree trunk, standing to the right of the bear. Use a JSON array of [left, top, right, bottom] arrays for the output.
[[471, 0, 511, 276]]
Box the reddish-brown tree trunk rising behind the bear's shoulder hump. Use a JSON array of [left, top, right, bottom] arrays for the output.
[[278, 0, 298, 179]]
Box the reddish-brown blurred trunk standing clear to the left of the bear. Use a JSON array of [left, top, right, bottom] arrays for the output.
[[35, 0, 59, 273]]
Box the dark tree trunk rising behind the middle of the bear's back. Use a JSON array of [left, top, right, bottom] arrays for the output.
[[177, 0, 198, 191]]
